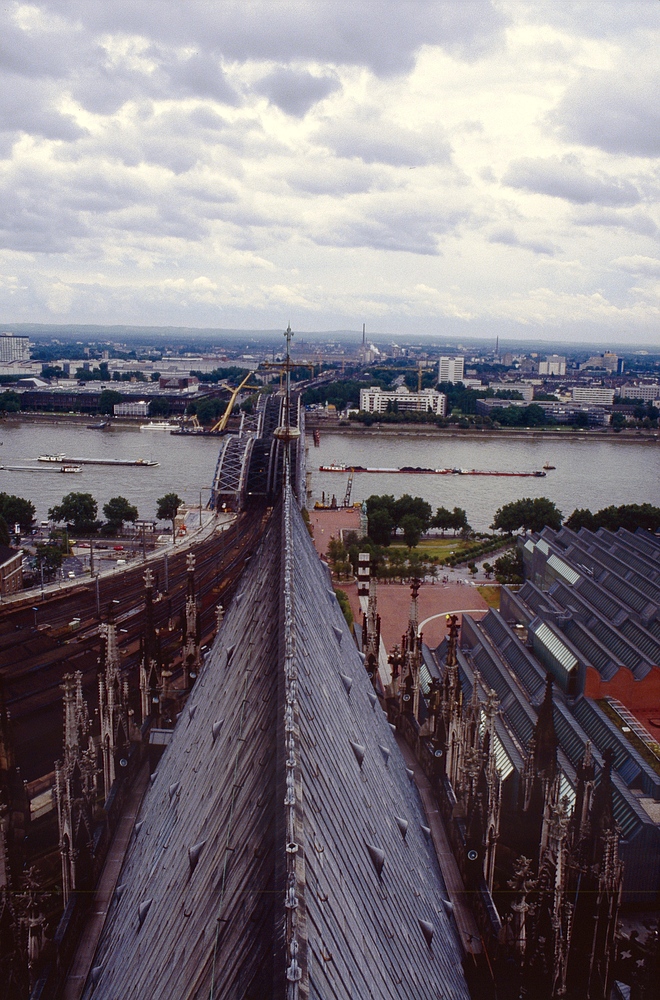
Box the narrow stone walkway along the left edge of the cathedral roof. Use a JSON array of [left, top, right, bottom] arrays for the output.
[[62, 761, 149, 1000]]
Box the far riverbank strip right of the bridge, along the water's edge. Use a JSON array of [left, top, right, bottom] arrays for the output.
[[305, 414, 660, 445]]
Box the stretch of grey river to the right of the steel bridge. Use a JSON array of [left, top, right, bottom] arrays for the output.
[[307, 431, 660, 531]]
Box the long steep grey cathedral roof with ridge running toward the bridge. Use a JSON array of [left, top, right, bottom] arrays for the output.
[[85, 492, 468, 1000]]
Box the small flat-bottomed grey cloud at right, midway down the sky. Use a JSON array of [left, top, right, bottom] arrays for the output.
[[502, 153, 641, 206]]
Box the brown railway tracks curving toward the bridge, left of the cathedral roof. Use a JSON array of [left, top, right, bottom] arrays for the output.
[[0, 509, 265, 781]]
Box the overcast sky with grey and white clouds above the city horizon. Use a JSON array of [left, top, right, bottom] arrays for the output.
[[0, 0, 660, 346]]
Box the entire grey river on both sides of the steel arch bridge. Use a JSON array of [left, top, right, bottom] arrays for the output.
[[0, 421, 660, 530]]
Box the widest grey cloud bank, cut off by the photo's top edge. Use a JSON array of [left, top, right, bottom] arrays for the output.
[[41, 0, 506, 75]]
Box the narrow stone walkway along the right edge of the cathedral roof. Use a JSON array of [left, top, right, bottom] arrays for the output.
[[396, 735, 483, 955]]
